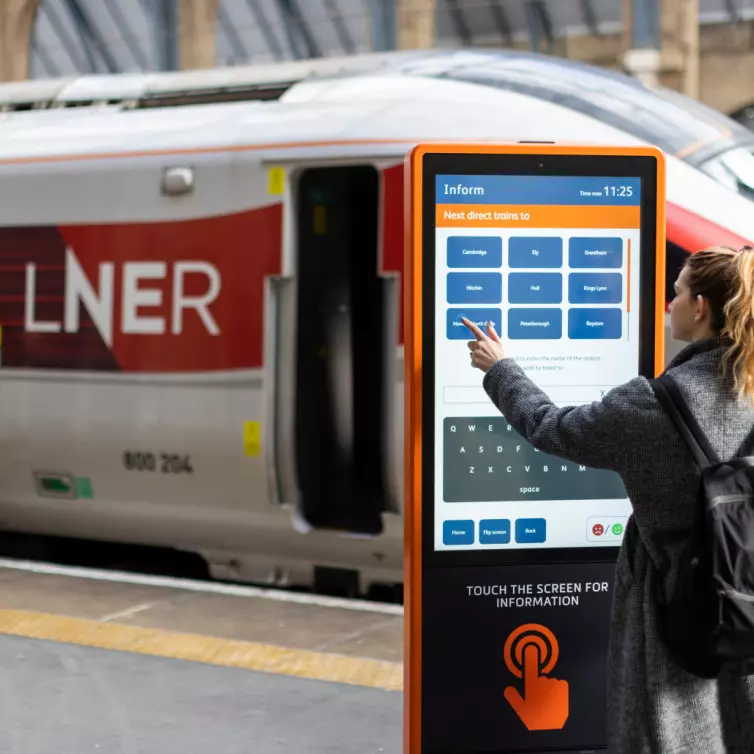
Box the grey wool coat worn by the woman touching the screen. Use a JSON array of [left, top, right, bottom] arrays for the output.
[[483, 338, 754, 754]]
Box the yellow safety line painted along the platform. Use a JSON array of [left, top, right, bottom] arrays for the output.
[[0, 609, 403, 691]]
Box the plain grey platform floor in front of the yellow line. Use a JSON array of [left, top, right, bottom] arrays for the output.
[[0, 636, 401, 754]]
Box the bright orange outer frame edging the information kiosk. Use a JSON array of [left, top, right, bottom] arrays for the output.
[[404, 142, 666, 754]]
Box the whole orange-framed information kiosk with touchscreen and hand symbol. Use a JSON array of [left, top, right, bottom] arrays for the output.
[[404, 143, 665, 754]]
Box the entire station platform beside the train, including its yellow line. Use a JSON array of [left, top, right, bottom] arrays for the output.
[[0, 561, 403, 754]]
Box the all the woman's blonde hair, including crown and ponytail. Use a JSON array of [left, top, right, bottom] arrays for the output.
[[684, 246, 754, 403]]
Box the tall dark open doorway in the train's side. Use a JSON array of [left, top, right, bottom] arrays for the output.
[[293, 166, 392, 535]]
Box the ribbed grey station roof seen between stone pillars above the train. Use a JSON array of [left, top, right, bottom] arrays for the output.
[[30, 0, 754, 78]]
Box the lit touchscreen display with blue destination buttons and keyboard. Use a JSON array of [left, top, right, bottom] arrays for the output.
[[434, 175, 642, 550]]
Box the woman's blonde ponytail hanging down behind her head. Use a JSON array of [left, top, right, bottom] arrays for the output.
[[723, 246, 754, 403]]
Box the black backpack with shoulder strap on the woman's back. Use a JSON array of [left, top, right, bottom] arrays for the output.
[[650, 374, 754, 678]]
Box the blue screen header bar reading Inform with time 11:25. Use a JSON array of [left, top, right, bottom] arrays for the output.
[[435, 175, 641, 207]]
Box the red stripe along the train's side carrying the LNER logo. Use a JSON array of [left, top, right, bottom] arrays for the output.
[[0, 173, 749, 373]]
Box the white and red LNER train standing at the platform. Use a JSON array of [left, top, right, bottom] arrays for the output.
[[0, 49, 754, 593]]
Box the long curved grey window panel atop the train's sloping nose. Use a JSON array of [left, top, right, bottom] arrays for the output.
[[442, 53, 754, 165]]
